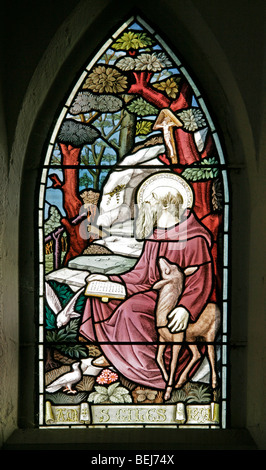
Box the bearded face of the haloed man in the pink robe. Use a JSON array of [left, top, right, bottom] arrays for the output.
[[136, 193, 183, 239]]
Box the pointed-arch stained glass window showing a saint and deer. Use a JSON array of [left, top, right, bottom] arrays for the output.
[[38, 16, 229, 428]]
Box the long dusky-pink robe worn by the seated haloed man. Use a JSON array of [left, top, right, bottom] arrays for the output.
[[80, 212, 213, 389]]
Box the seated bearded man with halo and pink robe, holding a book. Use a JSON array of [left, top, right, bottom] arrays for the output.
[[80, 172, 214, 390]]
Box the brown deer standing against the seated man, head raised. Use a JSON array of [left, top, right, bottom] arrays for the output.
[[153, 258, 221, 400]]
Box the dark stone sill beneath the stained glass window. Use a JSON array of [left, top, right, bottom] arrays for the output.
[[1, 428, 259, 452]]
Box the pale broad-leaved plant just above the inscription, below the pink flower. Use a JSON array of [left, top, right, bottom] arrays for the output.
[[88, 382, 132, 404]]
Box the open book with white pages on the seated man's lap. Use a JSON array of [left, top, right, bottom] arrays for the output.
[[85, 281, 126, 302]]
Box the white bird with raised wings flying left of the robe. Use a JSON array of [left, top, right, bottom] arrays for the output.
[[45, 282, 85, 328]]
